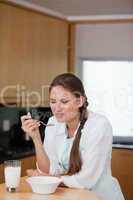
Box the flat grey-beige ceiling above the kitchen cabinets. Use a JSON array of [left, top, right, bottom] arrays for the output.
[[6, 0, 133, 19]]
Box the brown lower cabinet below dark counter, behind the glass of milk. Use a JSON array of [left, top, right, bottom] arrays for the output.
[[0, 156, 36, 183]]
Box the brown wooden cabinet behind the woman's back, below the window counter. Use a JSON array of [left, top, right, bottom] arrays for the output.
[[112, 148, 133, 200]]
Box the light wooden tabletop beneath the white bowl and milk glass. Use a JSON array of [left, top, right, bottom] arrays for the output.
[[0, 177, 102, 200]]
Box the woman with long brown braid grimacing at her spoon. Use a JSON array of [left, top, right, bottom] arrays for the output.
[[21, 73, 124, 200]]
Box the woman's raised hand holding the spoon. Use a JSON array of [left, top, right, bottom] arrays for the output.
[[21, 113, 40, 140]]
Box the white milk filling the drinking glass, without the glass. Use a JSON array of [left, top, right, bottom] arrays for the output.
[[5, 166, 21, 188]]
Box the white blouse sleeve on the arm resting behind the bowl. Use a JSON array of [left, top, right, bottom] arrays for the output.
[[61, 119, 112, 189]]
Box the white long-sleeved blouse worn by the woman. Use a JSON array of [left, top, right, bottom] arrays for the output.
[[44, 112, 124, 200]]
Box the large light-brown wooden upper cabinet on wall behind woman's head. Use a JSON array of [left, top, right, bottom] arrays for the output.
[[0, 3, 68, 105]]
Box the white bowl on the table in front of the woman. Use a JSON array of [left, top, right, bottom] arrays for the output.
[[26, 176, 61, 194]]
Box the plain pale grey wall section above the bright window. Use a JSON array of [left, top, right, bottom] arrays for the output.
[[76, 24, 133, 60]]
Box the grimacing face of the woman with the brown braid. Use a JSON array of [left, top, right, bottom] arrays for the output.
[[50, 86, 83, 123]]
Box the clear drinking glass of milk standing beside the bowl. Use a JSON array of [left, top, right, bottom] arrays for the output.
[[4, 160, 21, 192]]
